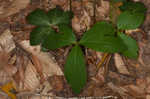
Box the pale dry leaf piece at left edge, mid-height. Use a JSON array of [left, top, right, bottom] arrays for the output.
[[0, 29, 15, 53]]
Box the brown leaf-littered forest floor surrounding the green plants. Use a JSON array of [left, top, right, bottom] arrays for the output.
[[0, 0, 150, 99]]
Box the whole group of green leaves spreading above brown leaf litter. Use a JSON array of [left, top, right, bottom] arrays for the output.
[[27, 0, 146, 94]]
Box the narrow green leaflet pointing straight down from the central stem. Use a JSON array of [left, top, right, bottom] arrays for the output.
[[64, 45, 87, 94]]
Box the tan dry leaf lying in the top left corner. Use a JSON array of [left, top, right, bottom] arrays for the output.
[[0, 0, 30, 19]]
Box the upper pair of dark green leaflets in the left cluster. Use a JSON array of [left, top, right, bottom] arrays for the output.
[[27, 7, 73, 26]]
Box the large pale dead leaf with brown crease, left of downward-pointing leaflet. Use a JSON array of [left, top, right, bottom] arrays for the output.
[[14, 41, 63, 91]]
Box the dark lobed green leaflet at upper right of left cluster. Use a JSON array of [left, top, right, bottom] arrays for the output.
[[48, 8, 73, 25]]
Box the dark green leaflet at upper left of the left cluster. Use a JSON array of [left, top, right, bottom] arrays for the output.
[[27, 9, 50, 26]]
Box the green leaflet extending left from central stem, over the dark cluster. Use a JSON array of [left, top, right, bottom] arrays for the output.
[[42, 25, 76, 50]]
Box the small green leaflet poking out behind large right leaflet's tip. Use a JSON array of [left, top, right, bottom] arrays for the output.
[[119, 33, 138, 59]]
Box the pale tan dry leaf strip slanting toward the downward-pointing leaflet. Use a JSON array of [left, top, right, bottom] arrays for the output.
[[20, 40, 63, 79]]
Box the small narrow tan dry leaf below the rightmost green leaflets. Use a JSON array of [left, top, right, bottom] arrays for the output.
[[114, 54, 130, 75]]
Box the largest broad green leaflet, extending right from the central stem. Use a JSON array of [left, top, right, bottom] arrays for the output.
[[79, 22, 126, 53]]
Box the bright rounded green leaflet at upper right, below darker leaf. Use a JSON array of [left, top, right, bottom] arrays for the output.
[[117, 11, 145, 30]]
